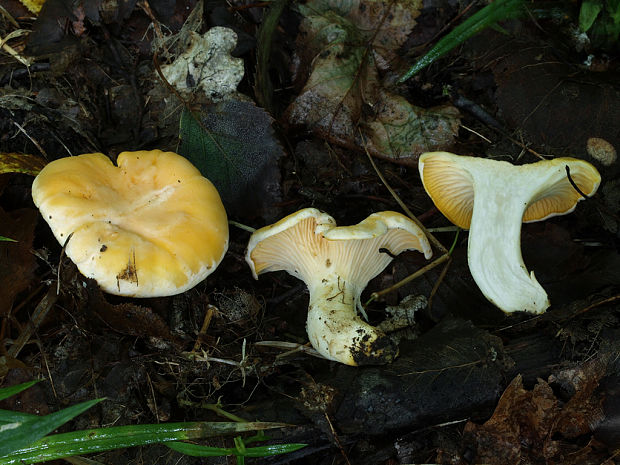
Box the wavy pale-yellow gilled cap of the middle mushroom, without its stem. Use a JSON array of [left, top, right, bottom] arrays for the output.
[[246, 208, 432, 284]]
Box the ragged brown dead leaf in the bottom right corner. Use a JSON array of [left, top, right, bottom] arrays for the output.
[[464, 357, 606, 465]]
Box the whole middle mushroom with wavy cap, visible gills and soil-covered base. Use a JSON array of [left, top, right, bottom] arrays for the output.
[[246, 208, 432, 365]]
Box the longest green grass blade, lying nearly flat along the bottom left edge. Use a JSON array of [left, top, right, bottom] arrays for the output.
[[0, 422, 287, 465]]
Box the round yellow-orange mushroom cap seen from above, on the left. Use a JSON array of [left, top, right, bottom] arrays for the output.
[[32, 150, 228, 297]]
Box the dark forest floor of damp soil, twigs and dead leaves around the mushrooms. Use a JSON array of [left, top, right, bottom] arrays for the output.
[[0, 0, 620, 465]]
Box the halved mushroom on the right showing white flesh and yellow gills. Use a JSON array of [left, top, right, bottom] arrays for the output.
[[419, 152, 601, 313]]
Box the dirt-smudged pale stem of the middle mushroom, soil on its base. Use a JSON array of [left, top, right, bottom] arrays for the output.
[[306, 273, 398, 365]]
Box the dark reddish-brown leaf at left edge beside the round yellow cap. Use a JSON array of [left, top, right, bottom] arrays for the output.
[[0, 208, 38, 317]]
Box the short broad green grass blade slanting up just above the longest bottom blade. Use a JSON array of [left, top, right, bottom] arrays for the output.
[[0, 399, 103, 457]]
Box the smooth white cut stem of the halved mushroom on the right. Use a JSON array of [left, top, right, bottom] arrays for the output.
[[467, 177, 549, 313]]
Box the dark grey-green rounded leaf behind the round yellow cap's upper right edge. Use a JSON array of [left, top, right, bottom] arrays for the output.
[[178, 100, 283, 217]]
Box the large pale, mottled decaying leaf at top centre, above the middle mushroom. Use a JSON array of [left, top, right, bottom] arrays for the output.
[[285, 0, 459, 165]]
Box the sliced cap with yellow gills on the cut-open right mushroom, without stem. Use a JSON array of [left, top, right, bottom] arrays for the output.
[[418, 152, 601, 229]]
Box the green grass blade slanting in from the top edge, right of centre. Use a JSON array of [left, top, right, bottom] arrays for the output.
[[398, 0, 525, 82]]
